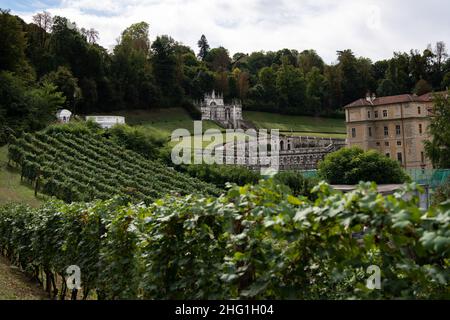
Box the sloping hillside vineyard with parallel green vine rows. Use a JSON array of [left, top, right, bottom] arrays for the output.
[[9, 132, 219, 203]]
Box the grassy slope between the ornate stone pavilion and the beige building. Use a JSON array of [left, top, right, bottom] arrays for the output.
[[243, 111, 346, 138]]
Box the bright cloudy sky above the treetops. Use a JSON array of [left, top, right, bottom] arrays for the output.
[[0, 0, 450, 63]]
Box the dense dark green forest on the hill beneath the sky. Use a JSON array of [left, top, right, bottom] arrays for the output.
[[0, 10, 450, 141]]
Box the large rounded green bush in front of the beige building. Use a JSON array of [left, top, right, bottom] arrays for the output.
[[318, 147, 410, 184]]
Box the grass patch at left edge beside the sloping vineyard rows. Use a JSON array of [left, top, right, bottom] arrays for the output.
[[0, 146, 42, 207]]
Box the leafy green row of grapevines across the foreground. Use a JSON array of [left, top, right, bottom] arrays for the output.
[[0, 180, 450, 299]]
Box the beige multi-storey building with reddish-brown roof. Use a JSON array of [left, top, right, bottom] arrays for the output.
[[345, 94, 433, 168]]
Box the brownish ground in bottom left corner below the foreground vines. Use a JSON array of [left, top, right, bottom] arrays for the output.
[[0, 256, 47, 300]]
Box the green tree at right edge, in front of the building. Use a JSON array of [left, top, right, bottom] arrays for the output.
[[425, 94, 450, 169]]
